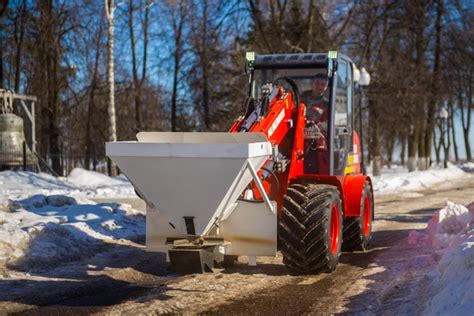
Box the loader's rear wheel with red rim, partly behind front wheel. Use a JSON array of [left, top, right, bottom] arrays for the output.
[[342, 182, 374, 251]]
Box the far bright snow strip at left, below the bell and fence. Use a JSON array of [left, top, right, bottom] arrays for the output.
[[0, 168, 137, 205]]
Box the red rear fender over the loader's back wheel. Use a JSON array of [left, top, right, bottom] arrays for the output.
[[342, 174, 374, 219]]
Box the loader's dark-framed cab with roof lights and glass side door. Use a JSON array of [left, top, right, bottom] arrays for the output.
[[247, 52, 354, 175]]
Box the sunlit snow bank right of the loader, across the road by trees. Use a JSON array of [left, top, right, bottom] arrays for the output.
[[372, 164, 468, 194]]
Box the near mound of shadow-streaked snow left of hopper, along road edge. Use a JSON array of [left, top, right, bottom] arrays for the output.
[[0, 195, 145, 277]]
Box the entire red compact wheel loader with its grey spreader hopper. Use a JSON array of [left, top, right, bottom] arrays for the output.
[[106, 51, 374, 274]]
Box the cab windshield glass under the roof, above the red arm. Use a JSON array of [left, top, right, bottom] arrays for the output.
[[251, 68, 330, 104]]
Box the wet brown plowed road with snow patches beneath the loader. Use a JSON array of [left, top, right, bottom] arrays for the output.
[[0, 176, 474, 315]]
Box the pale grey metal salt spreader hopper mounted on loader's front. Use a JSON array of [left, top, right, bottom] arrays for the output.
[[106, 132, 277, 272]]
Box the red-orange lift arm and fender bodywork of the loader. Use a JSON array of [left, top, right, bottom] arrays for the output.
[[229, 89, 370, 217]]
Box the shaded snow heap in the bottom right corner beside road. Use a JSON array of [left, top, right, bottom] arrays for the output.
[[408, 202, 474, 315]]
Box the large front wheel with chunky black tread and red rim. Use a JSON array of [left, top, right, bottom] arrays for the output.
[[278, 184, 342, 274]]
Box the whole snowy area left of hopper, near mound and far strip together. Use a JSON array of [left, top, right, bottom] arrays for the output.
[[0, 169, 145, 278]]
